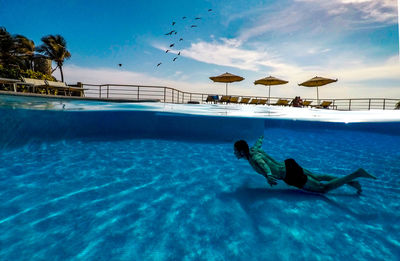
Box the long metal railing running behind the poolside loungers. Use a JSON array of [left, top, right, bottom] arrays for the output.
[[83, 84, 400, 111]]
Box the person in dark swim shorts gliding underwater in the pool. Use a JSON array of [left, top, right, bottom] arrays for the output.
[[234, 136, 376, 193]]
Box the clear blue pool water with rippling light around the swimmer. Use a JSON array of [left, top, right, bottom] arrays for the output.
[[0, 94, 400, 260]]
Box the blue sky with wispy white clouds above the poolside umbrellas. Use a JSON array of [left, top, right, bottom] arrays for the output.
[[0, 0, 400, 99]]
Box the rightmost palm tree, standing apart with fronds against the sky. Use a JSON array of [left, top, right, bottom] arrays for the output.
[[37, 35, 71, 81]]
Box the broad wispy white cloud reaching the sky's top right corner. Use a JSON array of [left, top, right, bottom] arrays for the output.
[[237, 0, 398, 41]]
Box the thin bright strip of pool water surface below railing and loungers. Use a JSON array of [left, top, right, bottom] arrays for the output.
[[0, 92, 400, 123]]
